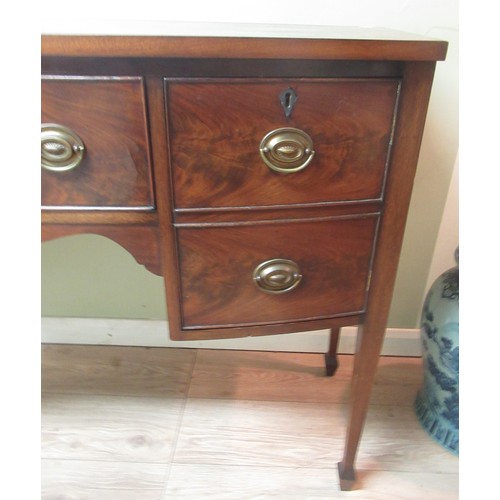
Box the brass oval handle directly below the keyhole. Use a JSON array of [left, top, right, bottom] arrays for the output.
[[259, 128, 314, 174]]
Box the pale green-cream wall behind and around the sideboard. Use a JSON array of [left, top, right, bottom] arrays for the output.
[[41, 0, 458, 328]]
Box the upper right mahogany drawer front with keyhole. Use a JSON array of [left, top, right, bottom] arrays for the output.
[[166, 79, 399, 208]]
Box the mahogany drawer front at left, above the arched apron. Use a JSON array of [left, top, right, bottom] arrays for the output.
[[41, 77, 154, 209]]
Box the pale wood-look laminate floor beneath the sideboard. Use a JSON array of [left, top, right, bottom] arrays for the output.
[[41, 344, 458, 500]]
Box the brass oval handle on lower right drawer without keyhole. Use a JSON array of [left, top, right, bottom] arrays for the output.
[[253, 259, 302, 294]]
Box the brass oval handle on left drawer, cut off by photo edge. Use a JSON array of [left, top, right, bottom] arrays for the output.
[[42, 123, 85, 172]]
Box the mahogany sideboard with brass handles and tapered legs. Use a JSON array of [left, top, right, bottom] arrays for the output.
[[41, 28, 447, 489]]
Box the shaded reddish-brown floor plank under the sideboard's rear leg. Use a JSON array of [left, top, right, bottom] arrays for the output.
[[189, 350, 422, 406]]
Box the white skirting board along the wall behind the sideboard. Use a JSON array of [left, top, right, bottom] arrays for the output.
[[41, 317, 422, 356]]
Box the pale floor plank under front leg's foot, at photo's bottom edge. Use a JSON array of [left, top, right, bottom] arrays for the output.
[[163, 464, 458, 500]]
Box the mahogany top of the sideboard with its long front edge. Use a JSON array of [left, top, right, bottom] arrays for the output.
[[42, 31, 448, 61]]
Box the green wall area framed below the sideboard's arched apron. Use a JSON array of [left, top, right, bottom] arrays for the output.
[[41, 234, 166, 319]]
